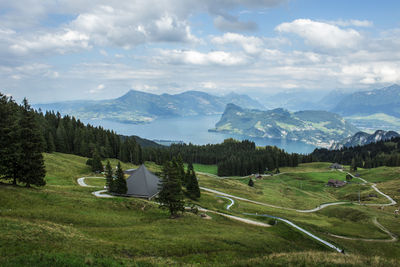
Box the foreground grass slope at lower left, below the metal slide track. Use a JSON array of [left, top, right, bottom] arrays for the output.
[[0, 153, 338, 266]]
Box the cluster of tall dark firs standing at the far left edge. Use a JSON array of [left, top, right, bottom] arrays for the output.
[[0, 94, 46, 187]]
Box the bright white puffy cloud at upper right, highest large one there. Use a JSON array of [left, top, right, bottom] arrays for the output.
[[275, 19, 362, 50]]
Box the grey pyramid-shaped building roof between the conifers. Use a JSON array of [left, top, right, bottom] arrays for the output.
[[126, 165, 160, 199]]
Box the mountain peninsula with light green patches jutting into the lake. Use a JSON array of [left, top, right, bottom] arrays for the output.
[[210, 104, 358, 147]]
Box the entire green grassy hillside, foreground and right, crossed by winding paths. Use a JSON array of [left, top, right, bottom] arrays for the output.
[[0, 156, 400, 266]]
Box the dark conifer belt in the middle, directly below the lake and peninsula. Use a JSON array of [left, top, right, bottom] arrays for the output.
[[143, 139, 299, 176]]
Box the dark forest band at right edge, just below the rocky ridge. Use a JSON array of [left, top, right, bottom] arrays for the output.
[[310, 137, 400, 169]]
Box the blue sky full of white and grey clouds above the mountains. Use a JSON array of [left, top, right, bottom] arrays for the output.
[[0, 0, 400, 103]]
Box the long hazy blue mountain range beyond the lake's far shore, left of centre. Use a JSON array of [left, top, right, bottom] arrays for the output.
[[33, 90, 264, 123]]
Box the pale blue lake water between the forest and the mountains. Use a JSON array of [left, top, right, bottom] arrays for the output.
[[82, 115, 315, 154]]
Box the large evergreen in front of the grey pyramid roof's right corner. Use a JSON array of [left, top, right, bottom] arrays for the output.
[[157, 160, 185, 217]]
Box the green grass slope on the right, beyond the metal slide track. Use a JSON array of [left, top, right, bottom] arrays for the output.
[[200, 163, 400, 260]]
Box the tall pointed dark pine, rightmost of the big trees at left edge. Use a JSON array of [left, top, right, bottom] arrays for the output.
[[19, 99, 46, 187]]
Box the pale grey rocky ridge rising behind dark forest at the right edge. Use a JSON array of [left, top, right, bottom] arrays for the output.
[[330, 130, 400, 150]]
